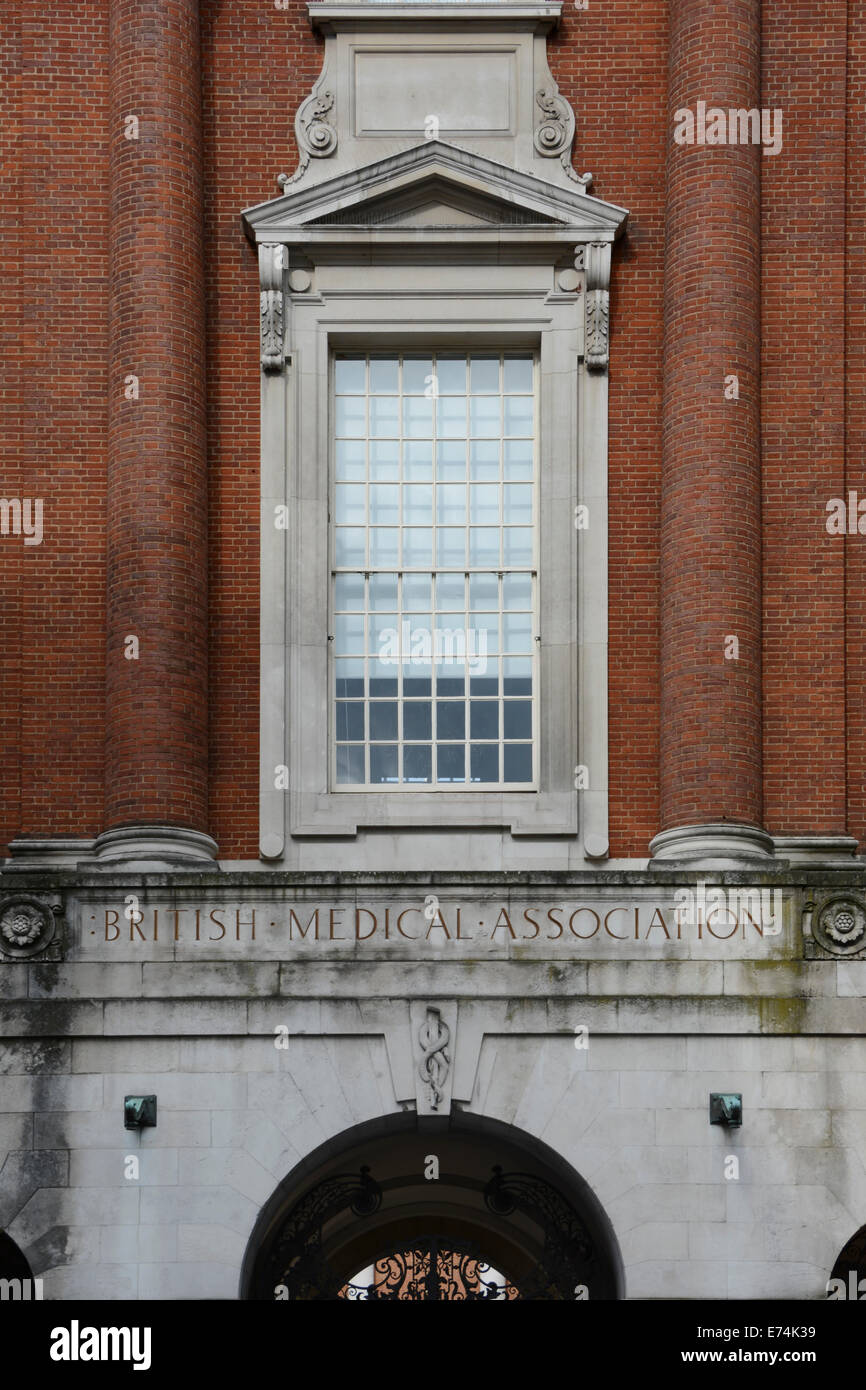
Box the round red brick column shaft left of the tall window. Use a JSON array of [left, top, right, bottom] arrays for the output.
[[106, 0, 209, 830]]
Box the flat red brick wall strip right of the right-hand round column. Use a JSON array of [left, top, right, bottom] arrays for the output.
[[760, 0, 862, 834]]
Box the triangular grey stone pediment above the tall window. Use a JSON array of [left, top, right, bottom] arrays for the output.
[[243, 140, 628, 242]]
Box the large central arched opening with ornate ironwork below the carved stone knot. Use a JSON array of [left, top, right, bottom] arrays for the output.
[[240, 1112, 623, 1301]]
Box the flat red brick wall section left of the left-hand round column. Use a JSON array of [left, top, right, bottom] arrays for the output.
[[0, 0, 108, 844]]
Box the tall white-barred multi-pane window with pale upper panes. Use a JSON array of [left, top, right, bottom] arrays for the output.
[[331, 349, 538, 791]]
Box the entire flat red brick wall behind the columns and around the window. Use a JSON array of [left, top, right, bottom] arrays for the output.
[[0, 0, 866, 858]]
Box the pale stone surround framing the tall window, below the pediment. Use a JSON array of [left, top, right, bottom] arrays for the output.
[[250, 214, 622, 866]]
